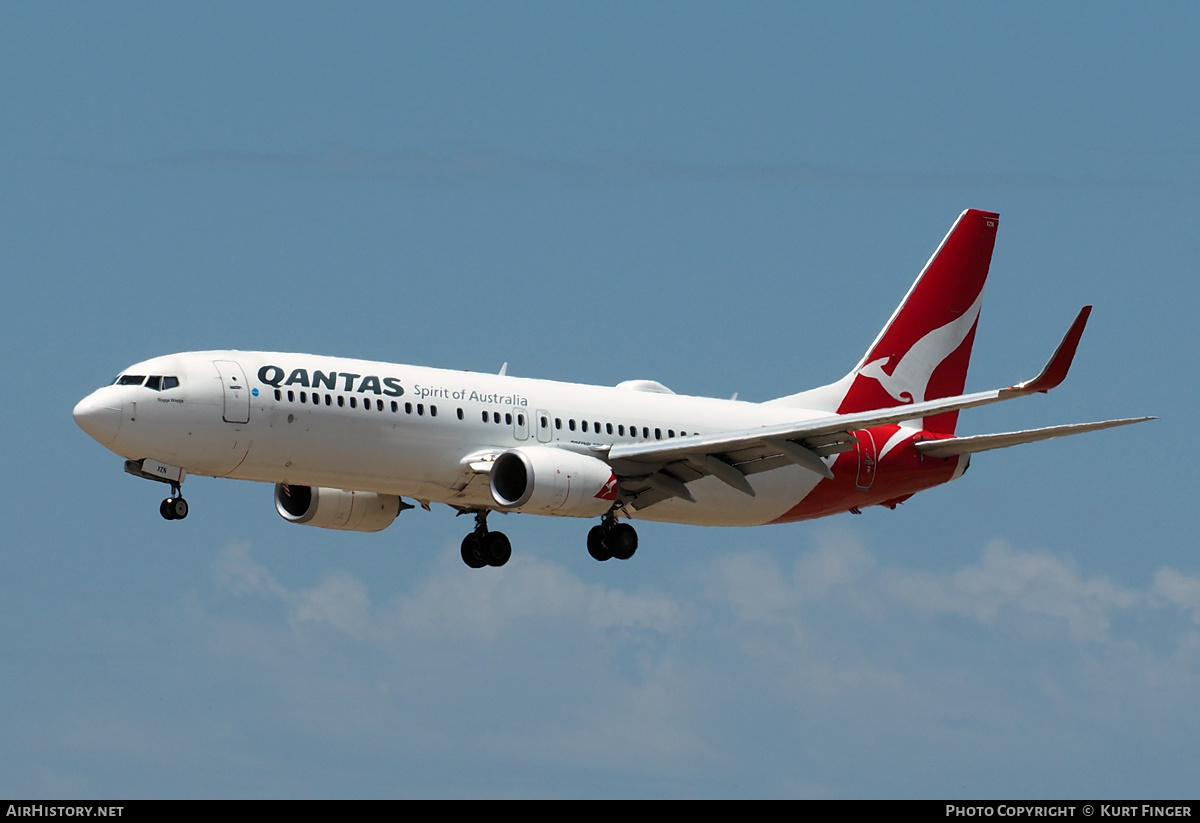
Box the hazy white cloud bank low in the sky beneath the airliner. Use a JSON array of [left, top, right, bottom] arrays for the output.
[[178, 531, 1200, 794]]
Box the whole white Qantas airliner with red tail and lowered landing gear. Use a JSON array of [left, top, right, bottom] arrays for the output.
[[74, 210, 1150, 569]]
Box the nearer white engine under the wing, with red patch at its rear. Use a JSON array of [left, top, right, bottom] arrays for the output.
[[490, 446, 617, 517]]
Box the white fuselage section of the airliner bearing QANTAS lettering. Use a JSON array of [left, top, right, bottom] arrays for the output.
[[76, 350, 823, 525]]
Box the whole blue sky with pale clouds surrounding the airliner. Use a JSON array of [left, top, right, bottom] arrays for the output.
[[0, 2, 1200, 798]]
